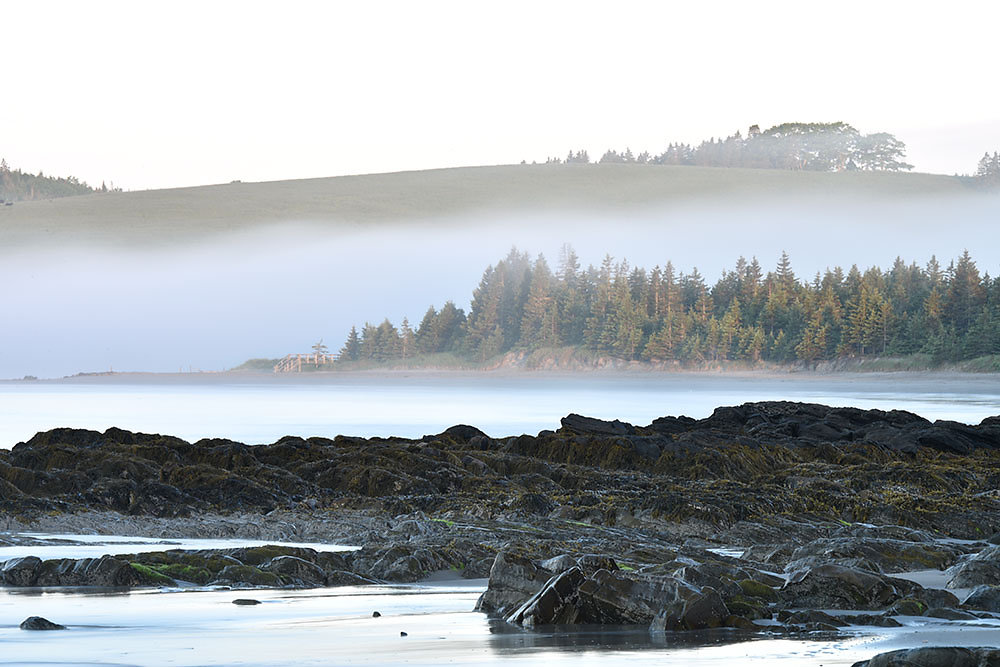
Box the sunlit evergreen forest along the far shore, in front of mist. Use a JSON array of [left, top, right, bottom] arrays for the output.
[[339, 246, 1000, 364]]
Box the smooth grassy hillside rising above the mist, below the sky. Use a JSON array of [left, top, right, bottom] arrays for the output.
[[0, 164, 972, 247]]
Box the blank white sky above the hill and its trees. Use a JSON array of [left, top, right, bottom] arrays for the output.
[[0, 0, 1000, 189]]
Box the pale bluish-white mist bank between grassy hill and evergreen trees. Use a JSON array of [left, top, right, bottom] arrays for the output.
[[0, 197, 1000, 378]]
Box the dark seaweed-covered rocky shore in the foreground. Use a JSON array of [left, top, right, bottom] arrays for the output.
[[0, 402, 1000, 665]]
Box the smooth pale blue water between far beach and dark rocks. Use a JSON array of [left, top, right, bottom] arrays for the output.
[[0, 373, 1000, 447]]
